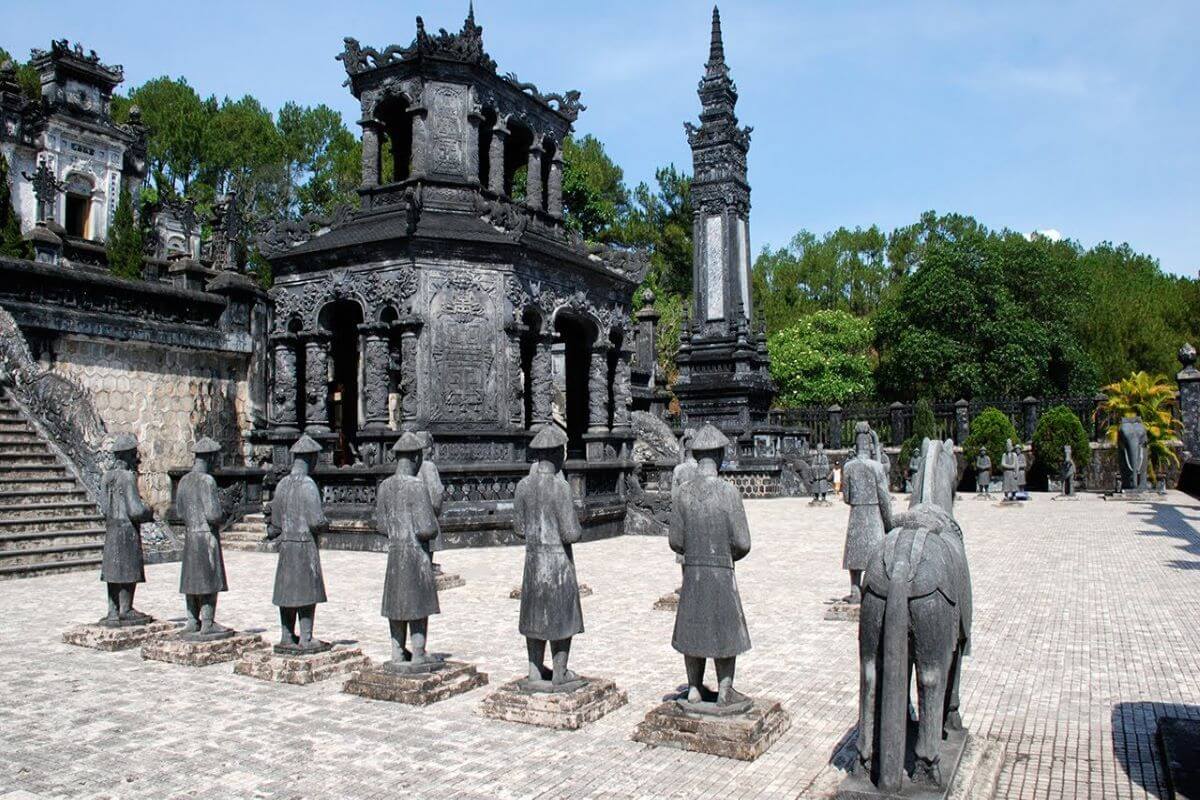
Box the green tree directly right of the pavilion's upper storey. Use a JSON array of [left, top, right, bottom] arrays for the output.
[[563, 133, 629, 241]]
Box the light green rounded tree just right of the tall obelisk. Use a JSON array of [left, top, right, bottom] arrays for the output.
[[767, 311, 874, 407]]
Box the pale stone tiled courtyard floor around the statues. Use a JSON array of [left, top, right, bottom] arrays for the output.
[[0, 494, 1200, 799]]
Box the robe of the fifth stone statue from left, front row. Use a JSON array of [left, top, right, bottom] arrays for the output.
[[512, 464, 583, 642]]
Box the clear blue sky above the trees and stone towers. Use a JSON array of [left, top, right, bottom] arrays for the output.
[[0, 0, 1200, 277]]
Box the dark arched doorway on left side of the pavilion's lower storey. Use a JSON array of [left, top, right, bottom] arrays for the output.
[[320, 300, 362, 467]]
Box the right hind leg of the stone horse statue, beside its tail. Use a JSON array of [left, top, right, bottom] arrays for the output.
[[908, 591, 958, 786]]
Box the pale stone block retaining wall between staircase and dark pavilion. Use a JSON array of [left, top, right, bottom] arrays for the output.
[[43, 336, 251, 515]]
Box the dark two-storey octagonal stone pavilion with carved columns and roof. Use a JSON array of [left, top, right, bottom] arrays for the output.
[[253, 13, 647, 547]]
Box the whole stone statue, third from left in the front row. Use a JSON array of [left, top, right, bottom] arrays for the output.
[[266, 434, 330, 654]]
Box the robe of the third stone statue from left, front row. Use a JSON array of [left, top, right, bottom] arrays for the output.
[[271, 474, 326, 608]]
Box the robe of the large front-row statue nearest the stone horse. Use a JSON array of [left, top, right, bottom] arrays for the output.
[[668, 471, 750, 658]]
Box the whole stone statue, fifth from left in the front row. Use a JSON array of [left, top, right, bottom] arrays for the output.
[[512, 423, 583, 687]]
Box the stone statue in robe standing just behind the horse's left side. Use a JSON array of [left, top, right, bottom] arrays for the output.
[[841, 422, 892, 603]]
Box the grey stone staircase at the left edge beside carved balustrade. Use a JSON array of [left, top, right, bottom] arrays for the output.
[[0, 392, 104, 579]]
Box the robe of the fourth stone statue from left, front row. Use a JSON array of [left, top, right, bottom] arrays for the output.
[[374, 475, 442, 620]]
